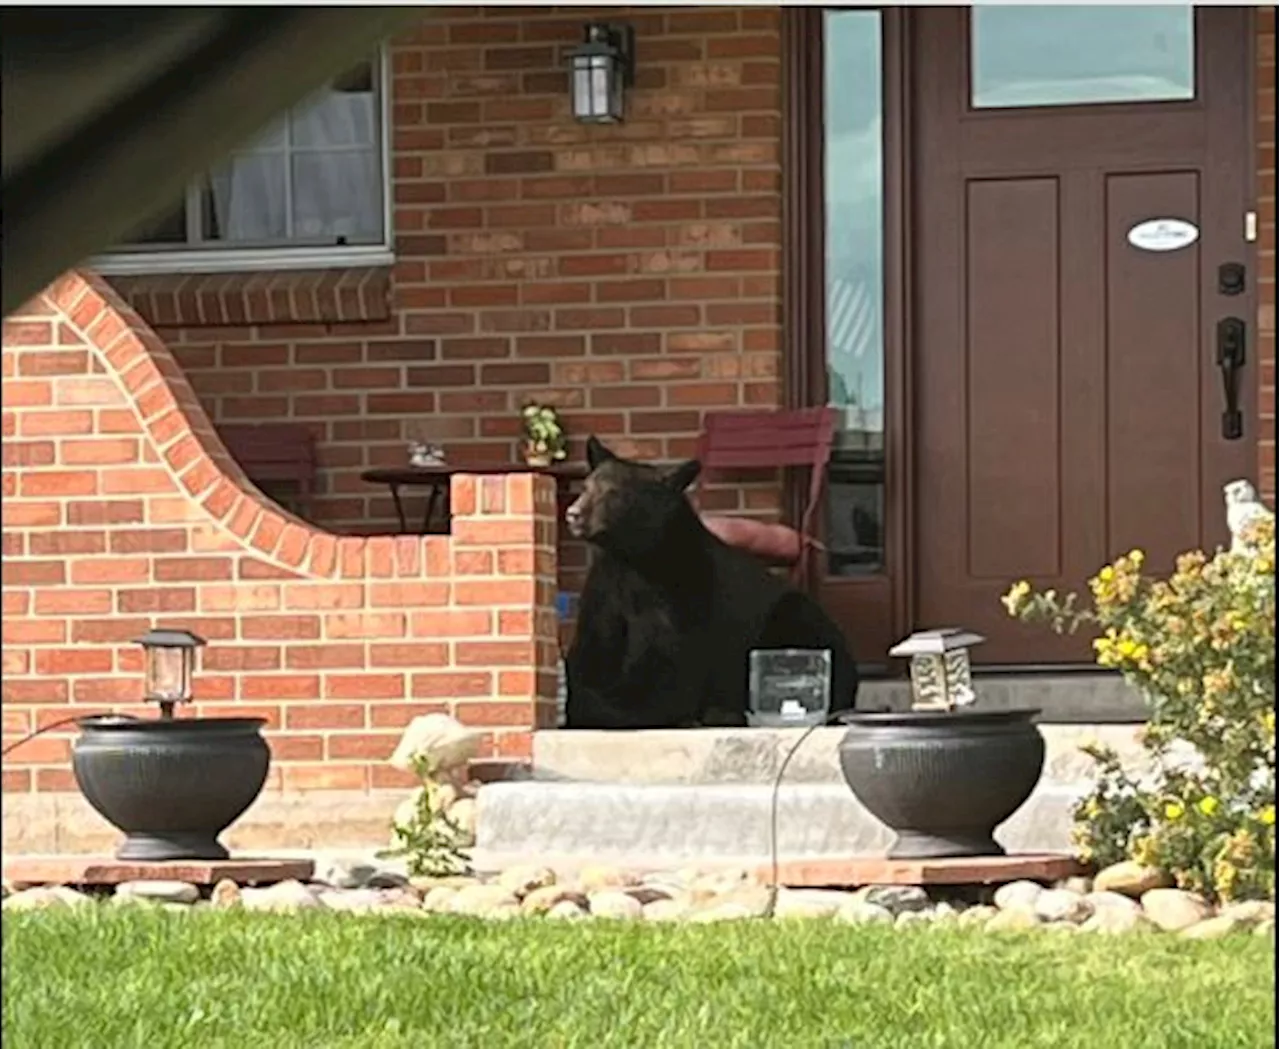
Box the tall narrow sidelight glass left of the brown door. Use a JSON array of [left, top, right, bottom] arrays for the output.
[[823, 10, 884, 576]]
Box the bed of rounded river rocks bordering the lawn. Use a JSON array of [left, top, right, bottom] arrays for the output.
[[4, 860, 1275, 939]]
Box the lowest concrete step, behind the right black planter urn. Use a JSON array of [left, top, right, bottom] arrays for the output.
[[476, 779, 1079, 867]]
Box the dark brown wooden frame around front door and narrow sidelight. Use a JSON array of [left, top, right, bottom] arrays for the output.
[[781, 6, 1261, 673]]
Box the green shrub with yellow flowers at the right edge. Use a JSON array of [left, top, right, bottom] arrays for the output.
[[1004, 519, 1276, 899]]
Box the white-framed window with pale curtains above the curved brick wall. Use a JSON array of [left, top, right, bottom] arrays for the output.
[[95, 56, 390, 274]]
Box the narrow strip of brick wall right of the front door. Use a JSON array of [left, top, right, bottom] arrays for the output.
[[1254, 8, 1276, 505]]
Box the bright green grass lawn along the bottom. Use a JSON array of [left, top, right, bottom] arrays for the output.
[[4, 907, 1275, 1049]]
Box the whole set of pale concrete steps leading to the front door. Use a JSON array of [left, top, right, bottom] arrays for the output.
[[476, 674, 1148, 866]]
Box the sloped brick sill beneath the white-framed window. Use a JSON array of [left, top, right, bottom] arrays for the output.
[[92, 256, 392, 327]]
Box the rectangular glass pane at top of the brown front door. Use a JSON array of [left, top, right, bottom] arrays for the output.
[[970, 4, 1196, 109]]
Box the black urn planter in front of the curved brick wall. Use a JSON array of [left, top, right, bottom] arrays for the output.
[[72, 716, 271, 861]]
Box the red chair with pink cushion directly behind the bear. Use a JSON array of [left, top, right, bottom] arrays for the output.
[[696, 408, 836, 586]]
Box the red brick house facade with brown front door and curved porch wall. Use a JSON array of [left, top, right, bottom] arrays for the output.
[[4, 6, 1276, 854]]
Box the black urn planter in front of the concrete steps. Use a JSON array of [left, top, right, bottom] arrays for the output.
[[840, 710, 1044, 860]]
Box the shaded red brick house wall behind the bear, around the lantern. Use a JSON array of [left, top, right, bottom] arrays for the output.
[[129, 8, 781, 564]]
